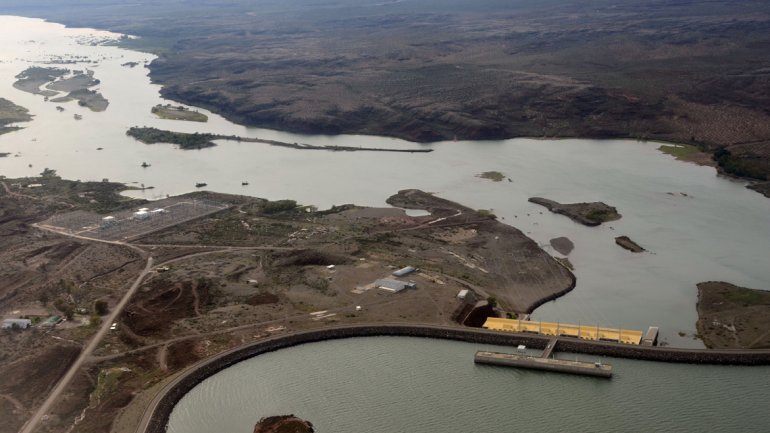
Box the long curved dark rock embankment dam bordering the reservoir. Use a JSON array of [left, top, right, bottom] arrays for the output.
[[141, 324, 770, 433]]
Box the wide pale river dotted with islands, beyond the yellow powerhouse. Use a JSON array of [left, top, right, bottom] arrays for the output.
[[0, 17, 770, 347]]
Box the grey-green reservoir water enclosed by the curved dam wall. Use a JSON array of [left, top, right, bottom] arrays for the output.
[[168, 337, 770, 433]]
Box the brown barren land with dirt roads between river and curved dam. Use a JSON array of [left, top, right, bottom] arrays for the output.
[[0, 172, 574, 433]]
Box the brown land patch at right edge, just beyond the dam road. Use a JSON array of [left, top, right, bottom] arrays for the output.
[[697, 281, 770, 349]]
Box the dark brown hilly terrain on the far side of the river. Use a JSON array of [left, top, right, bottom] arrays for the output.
[[0, 0, 770, 180]]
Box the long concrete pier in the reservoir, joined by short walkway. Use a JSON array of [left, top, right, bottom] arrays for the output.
[[473, 337, 612, 379]]
